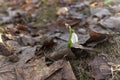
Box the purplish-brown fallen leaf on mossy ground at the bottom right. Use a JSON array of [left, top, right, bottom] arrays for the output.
[[89, 56, 112, 80]]
